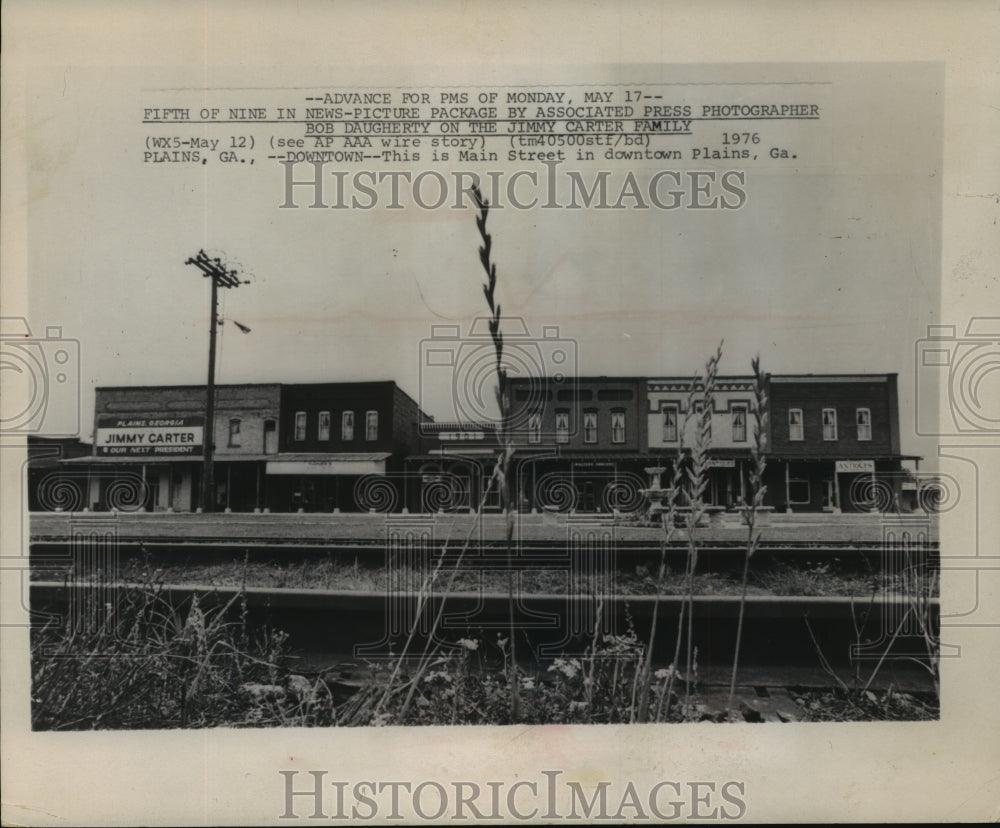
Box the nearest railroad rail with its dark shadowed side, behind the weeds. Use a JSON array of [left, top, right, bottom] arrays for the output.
[[30, 581, 940, 700]]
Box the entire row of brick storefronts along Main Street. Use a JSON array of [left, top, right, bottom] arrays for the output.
[[29, 374, 919, 513]]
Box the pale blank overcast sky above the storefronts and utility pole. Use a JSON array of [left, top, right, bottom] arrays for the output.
[[28, 64, 942, 466]]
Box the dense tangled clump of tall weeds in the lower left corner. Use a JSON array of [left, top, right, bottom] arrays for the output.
[[32, 585, 331, 730]]
